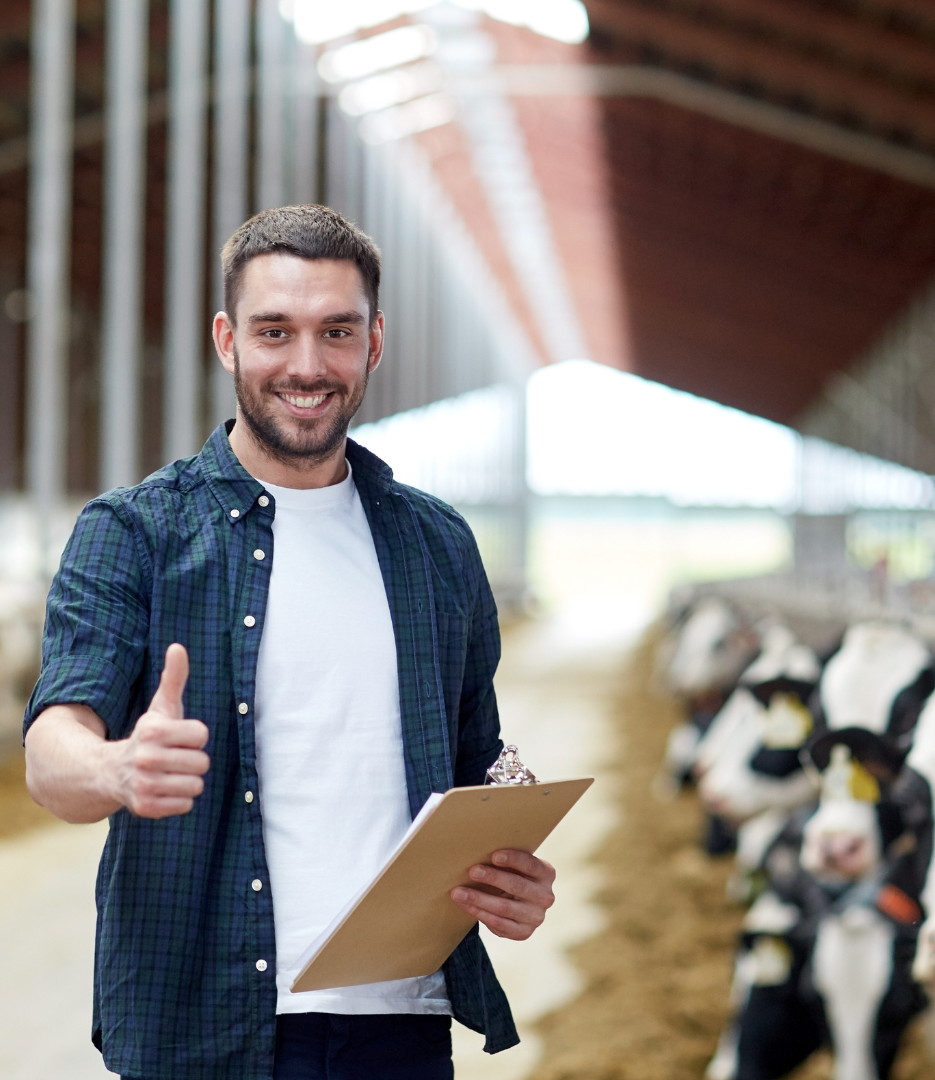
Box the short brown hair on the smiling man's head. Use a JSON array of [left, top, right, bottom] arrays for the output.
[[220, 205, 380, 323]]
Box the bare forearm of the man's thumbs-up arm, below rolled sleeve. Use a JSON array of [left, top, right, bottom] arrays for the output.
[[26, 705, 122, 824]]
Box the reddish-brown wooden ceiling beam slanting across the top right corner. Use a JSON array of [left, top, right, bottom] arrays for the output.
[[588, 0, 935, 147]]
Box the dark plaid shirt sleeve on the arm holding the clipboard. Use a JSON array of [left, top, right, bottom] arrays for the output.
[[455, 538, 503, 787]]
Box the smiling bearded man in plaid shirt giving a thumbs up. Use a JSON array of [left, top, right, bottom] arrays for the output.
[[25, 206, 554, 1080]]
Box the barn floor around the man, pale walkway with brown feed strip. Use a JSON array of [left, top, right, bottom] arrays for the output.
[[0, 624, 935, 1080]]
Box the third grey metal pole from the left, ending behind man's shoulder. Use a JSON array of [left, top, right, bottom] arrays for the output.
[[163, 0, 207, 460]]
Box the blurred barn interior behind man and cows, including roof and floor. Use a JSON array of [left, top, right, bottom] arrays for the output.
[[0, 0, 935, 1080]]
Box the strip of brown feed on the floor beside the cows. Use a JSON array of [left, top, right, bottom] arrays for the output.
[[530, 635, 935, 1080]]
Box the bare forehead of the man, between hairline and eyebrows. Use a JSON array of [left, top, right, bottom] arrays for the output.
[[238, 252, 367, 318]]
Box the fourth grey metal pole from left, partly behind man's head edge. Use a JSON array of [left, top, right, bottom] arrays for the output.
[[211, 0, 250, 424]]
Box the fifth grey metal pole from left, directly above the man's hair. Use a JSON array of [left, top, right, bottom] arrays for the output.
[[255, 0, 286, 211]]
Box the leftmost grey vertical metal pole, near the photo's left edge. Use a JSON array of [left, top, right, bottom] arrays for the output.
[[26, 0, 74, 544]]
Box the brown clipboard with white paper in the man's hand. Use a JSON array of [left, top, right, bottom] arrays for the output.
[[290, 777, 594, 993]]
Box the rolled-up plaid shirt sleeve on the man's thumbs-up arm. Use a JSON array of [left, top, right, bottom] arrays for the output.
[[23, 499, 150, 739]]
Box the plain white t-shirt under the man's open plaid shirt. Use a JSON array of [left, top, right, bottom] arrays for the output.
[[256, 465, 451, 1014]]
